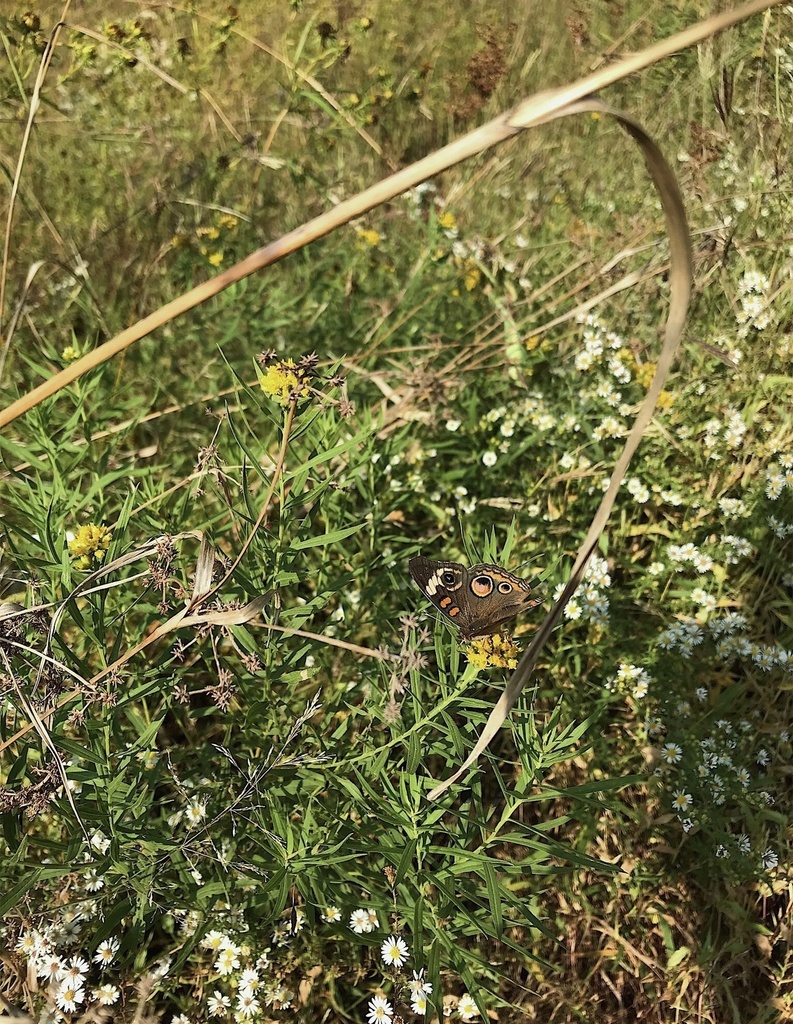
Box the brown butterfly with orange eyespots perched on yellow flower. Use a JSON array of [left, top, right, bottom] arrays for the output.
[[408, 555, 542, 640]]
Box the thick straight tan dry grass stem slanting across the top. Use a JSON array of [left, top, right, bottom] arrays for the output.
[[0, 0, 782, 427]]
